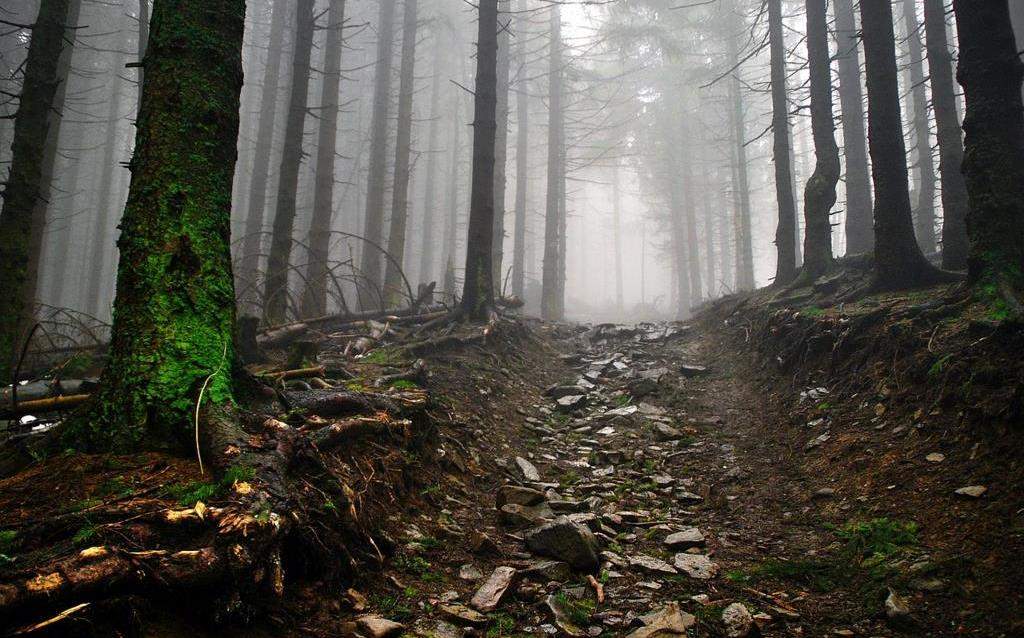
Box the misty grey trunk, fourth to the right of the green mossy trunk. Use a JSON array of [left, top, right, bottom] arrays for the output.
[[358, 0, 395, 310]]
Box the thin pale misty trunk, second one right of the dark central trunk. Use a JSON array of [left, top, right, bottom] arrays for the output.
[[512, 25, 529, 299]]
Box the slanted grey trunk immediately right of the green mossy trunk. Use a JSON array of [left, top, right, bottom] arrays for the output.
[[239, 2, 288, 312]]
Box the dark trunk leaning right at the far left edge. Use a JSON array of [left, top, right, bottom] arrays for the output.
[[0, 0, 70, 383]]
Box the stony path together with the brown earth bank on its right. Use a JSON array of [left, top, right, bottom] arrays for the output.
[[0, 276, 1024, 638]]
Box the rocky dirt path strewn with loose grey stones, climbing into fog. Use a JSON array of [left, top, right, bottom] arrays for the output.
[[347, 325, 942, 638]]
